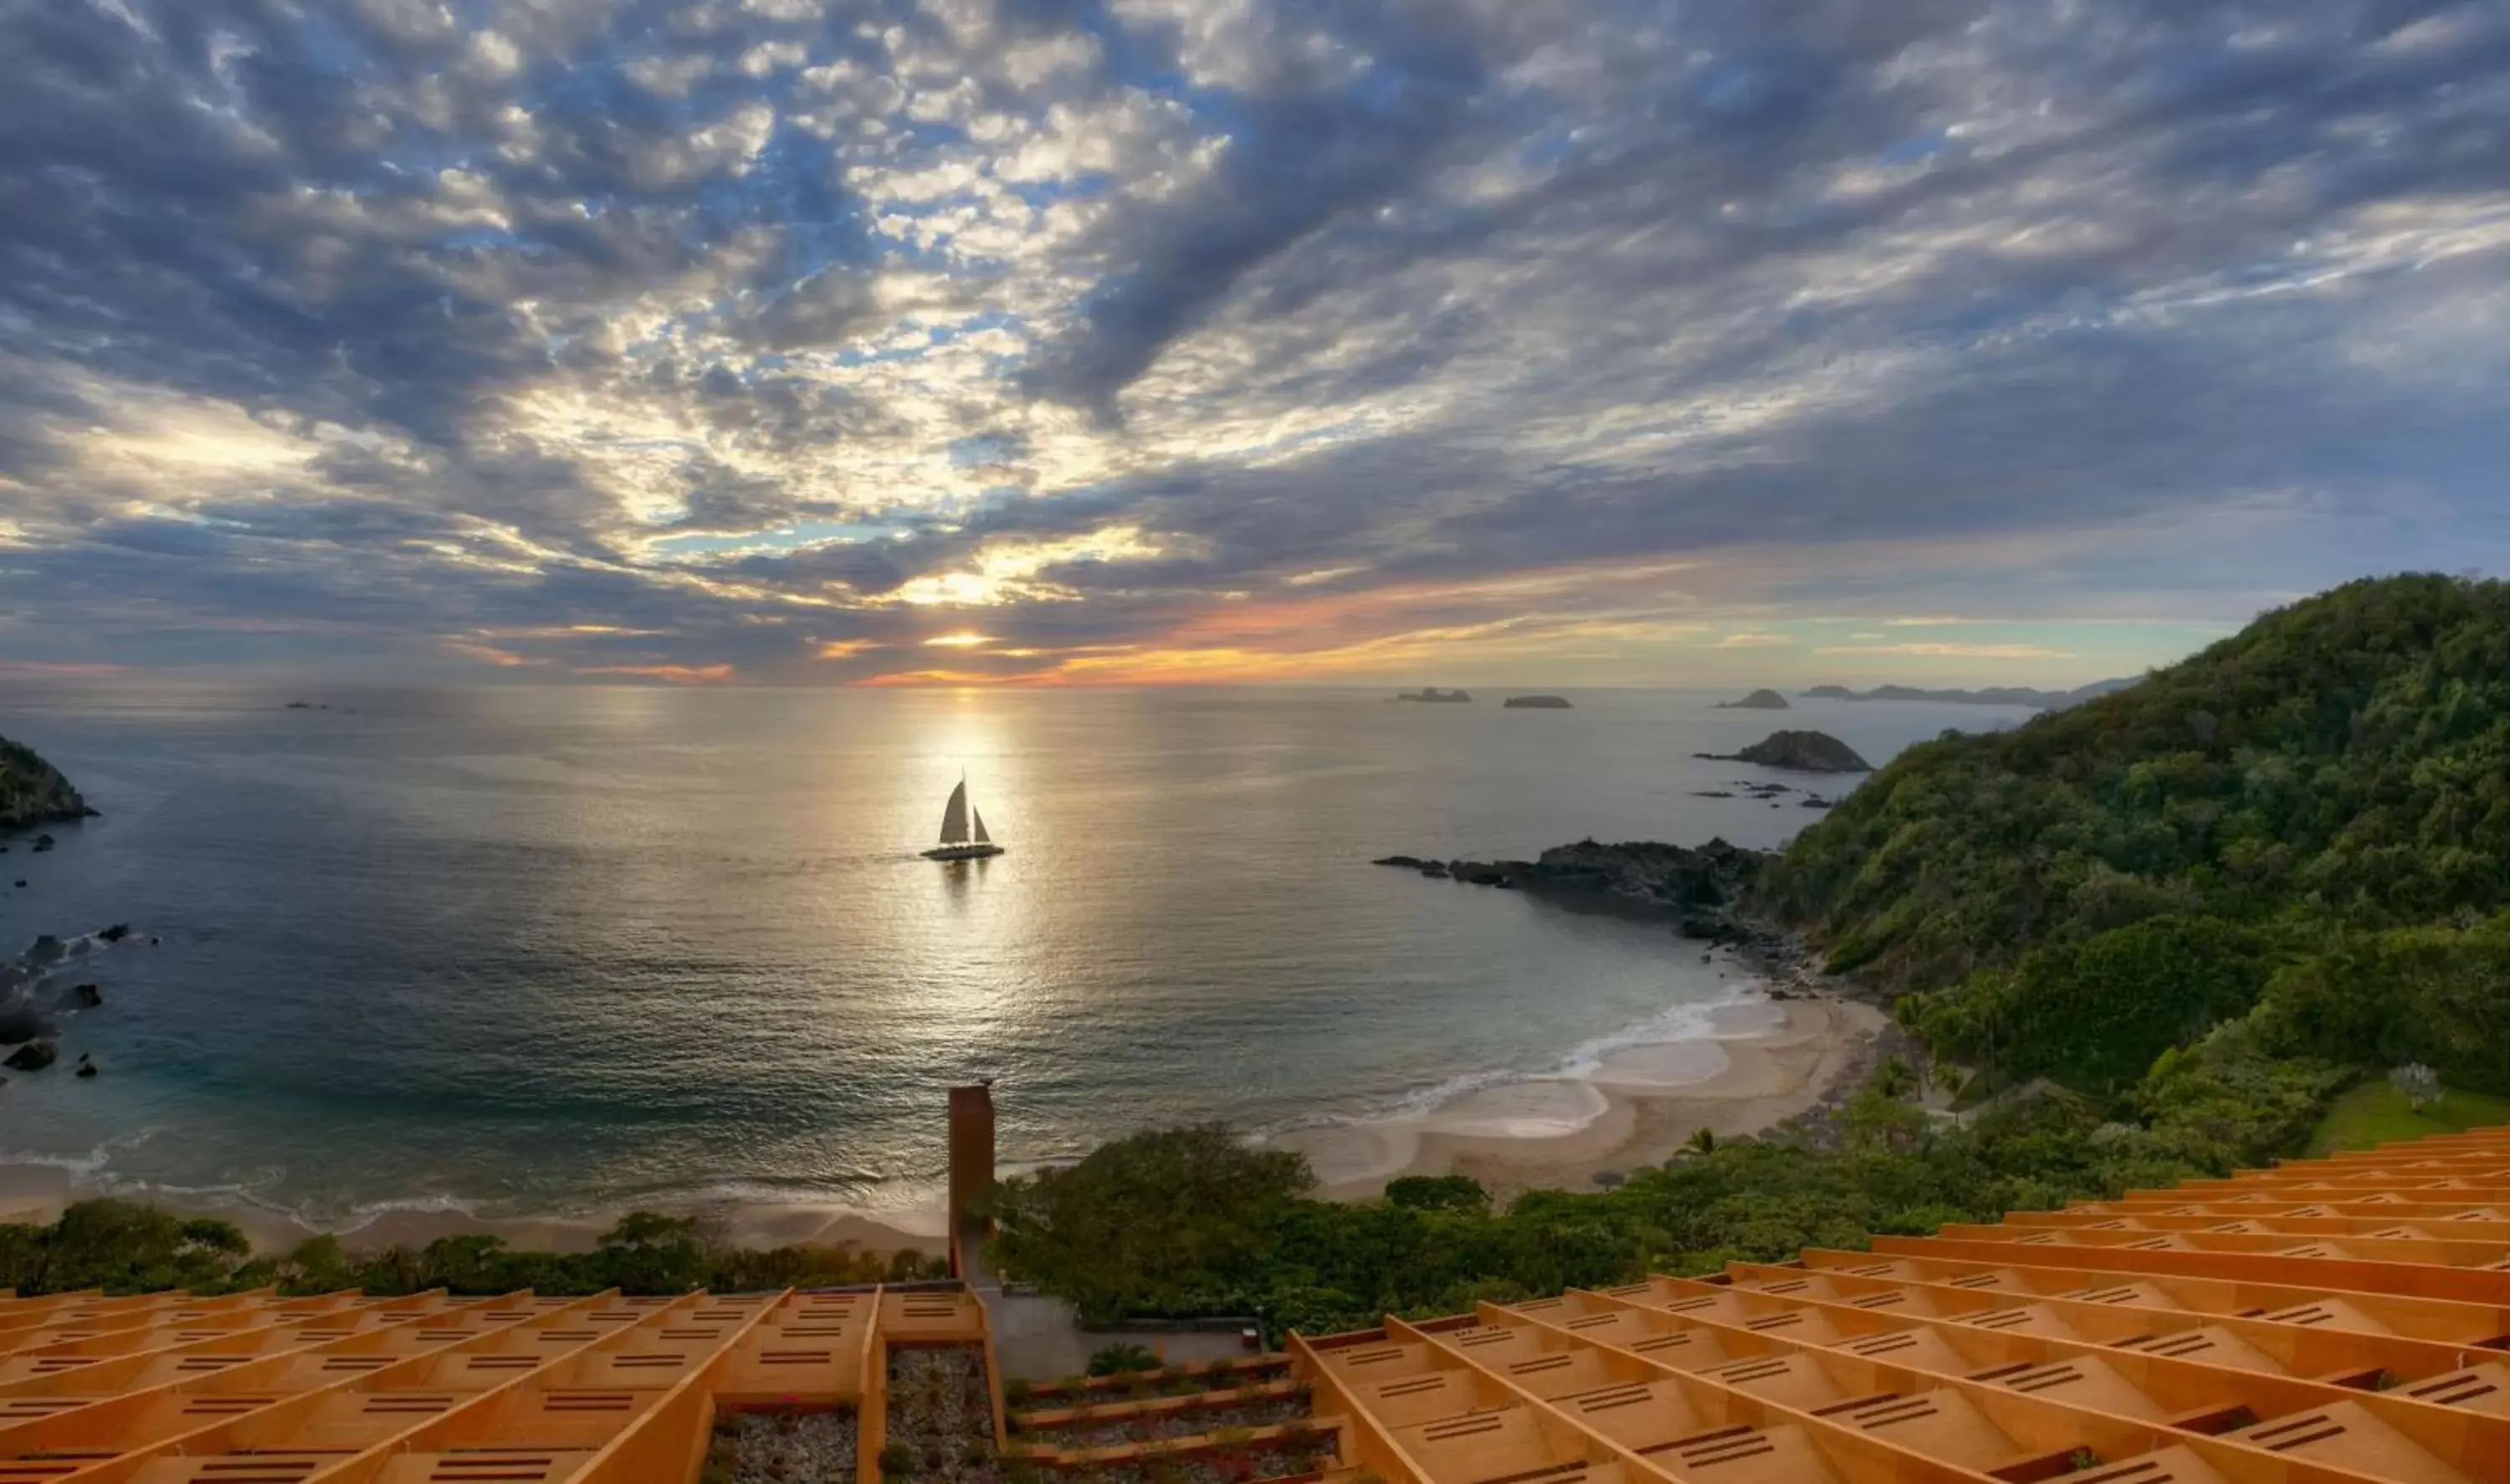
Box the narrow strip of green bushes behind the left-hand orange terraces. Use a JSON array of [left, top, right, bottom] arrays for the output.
[[0, 1200, 946, 1293]]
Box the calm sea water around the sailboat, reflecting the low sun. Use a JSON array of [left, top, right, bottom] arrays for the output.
[[0, 688, 2018, 1223]]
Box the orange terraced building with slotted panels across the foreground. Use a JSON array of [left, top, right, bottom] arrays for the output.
[[14, 1133, 2510, 1484]]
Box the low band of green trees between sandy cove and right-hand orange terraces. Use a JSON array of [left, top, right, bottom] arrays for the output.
[[991, 1045, 2342, 1333]]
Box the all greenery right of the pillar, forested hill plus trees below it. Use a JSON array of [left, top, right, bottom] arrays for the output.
[[994, 577, 2510, 1331]]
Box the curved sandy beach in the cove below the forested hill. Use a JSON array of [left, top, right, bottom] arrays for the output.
[[1275, 997, 1890, 1200]]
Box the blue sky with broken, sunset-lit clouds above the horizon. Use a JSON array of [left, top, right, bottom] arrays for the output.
[[0, 0, 2510, 688]]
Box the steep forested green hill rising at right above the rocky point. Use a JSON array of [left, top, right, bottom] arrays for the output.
[[1765, 575, 2510, 1093]]
